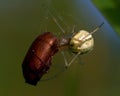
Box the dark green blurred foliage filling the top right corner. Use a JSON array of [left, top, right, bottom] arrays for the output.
[[92, 0, 120, 34]]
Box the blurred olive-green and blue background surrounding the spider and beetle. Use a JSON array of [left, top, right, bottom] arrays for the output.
[[0, 0, 120, 96]]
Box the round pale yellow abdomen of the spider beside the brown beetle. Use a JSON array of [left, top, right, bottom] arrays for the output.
[[70, 30, 94, 54]]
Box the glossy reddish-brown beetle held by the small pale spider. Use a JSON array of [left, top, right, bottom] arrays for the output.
[[22, 32, 58, 85]]
